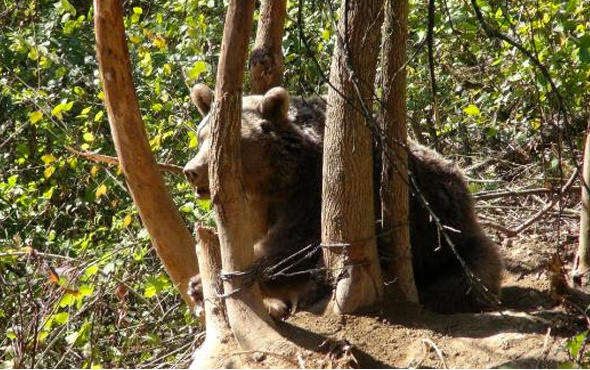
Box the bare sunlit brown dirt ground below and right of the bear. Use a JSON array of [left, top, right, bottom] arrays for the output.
[[286, 158, 586, 368]]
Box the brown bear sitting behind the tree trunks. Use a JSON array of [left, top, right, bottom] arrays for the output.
[[184, 85, 502, 316]]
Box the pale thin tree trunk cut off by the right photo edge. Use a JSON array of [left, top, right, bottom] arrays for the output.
[[574, 125, 590, 285]]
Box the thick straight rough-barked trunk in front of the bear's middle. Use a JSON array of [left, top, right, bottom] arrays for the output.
[[322, 0, 383, 313]]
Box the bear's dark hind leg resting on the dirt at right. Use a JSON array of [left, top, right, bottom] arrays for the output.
[[419, 233, 502, 313]]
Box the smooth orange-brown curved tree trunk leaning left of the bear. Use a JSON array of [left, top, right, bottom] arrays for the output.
[[94, 0, 198, 306]]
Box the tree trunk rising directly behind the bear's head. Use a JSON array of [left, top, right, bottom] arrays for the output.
[[250, 0, 287, 94]]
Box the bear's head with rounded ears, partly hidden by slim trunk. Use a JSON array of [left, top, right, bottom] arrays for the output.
[[184, 84, 293, 198]]
